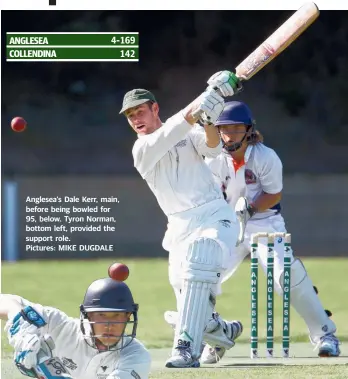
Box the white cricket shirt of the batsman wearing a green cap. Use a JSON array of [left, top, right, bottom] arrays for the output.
[[133, 112, 223, 216]]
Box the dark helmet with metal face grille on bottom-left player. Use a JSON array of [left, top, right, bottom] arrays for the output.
[[80, 278, 139, 350]]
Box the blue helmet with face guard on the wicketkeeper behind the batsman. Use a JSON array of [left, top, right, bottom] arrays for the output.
[[215, 101, 255, 152]]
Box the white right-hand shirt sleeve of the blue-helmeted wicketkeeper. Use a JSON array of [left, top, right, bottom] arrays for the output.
[[259, 150, 283, 194]]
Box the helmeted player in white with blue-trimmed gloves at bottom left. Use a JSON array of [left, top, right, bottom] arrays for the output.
[[0, 278, 151, 379]]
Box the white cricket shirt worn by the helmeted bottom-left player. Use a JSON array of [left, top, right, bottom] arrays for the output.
[[1, 295, 151, 379]]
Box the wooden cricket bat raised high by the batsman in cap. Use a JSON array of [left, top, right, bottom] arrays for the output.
[[194, 3, 320, 117]]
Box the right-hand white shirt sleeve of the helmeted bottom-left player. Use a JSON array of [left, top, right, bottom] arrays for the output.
[[106, 345, 151, 379]]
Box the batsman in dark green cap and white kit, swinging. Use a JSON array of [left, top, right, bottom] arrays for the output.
[[120, 71, 242, 368]]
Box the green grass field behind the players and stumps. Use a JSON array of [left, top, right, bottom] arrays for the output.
[[2, 258, 348, 379]]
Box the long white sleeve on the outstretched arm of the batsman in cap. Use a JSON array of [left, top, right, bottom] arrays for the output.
[[132, 112, 192, 178]]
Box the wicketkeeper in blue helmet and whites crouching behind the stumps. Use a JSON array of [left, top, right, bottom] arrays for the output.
[[202, 101, 340, 363]]
